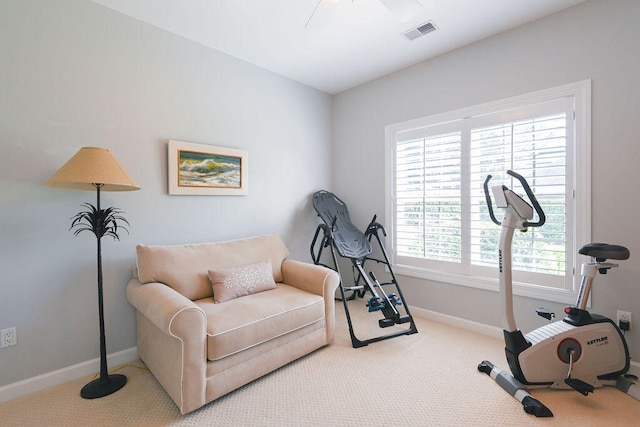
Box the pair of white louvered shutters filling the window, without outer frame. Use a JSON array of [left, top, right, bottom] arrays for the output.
[[394, 98, 572, 288]]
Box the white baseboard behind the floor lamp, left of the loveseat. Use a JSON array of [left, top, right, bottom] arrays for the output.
[[0, 347, 138, 402]]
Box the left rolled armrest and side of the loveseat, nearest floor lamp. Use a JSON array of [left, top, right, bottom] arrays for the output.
[[127, 279, 207, 414]]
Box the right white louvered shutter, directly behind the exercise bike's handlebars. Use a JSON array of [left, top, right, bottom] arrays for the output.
[[470, 99, 572, 288]]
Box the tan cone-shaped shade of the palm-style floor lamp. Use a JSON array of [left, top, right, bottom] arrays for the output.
[[45, 147, 140, 191]]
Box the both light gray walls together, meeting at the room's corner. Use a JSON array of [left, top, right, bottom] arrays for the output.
[[0, 0, 640, 392]]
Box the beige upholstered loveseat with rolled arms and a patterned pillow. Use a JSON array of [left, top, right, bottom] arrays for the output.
[[127, 234, 339, 414]]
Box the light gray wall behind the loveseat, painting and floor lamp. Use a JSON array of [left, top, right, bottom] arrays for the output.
[[0, 0, 332, 386]]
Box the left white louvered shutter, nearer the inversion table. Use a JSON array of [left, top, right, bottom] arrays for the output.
[[395, 121, 463, 272]]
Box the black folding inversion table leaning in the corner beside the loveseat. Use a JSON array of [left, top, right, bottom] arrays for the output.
[[310, 190, 418, 348]]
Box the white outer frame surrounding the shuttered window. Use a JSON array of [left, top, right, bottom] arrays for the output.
[[385, 80, 591, 304]]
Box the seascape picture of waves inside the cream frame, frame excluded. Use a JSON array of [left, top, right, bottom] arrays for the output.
[[178, 151, 242, 188]]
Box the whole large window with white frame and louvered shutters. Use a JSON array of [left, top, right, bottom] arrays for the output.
[[386, 81, 590, 303]]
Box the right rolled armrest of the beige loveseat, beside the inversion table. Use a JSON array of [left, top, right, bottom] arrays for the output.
[[282, 258, 340, 344]]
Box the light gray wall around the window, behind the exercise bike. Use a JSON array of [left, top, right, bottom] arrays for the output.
[[332, 0, 640, 359]]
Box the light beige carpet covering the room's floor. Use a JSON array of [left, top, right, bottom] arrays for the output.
[[0, 300, 640, 426]]
